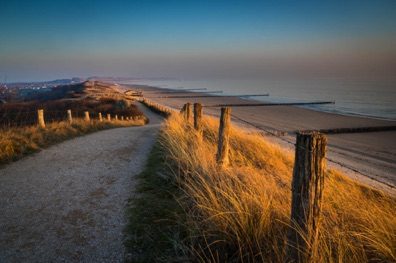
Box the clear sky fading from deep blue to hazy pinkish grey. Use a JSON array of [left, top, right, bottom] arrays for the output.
[[0, 0, 396, 82]]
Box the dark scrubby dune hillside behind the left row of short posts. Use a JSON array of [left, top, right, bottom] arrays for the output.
[[0, 81, 143, 126]]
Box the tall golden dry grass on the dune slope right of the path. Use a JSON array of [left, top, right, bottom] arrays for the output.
[[160, 115, 396, 262]]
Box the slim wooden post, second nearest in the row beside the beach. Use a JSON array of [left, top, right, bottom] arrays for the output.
[[216, 108, 231, 167]]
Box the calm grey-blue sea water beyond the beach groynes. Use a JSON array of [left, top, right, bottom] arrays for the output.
[[131, 78, 396, 121]]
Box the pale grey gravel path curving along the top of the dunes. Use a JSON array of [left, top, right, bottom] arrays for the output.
[[0, 104, 162, 262]]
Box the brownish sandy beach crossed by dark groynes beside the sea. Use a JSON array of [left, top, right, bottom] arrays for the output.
[[121, 87, 396, 195]]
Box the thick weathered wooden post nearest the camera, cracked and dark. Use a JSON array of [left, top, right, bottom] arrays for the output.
[[286, 132, 327, 262]]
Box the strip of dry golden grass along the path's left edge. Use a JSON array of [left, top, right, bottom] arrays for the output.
[[0, 118, 146, 165]]
